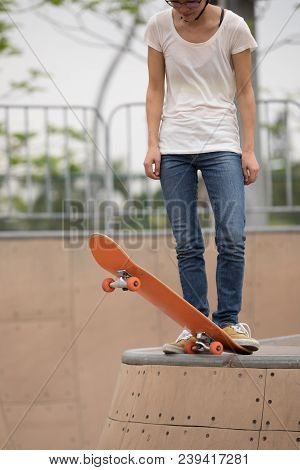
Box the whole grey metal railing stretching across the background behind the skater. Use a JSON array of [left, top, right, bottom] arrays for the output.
[[0, 100, 300, 236]]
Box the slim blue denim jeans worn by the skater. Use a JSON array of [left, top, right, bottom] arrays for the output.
[[160, 151, 246, 327]]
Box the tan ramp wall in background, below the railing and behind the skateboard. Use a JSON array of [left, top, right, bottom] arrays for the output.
[[0, 231, 300, 449]]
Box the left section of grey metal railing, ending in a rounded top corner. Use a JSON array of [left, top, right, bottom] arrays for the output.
[[0, 105, 108, 232]]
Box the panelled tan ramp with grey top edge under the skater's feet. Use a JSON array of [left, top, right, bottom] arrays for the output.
[[99, 335, 300, 450]]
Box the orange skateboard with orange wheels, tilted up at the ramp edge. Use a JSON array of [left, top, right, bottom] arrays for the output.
[[89, 234, 252, 355]]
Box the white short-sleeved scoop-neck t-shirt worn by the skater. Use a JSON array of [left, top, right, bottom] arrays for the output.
[[144, 8, 257, 155]]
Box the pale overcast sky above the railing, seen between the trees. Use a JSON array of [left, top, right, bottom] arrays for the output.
[[0, 0, 300, 173]]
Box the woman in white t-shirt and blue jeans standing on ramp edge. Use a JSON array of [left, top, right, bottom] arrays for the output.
[[144, 0, 259, 353]]
